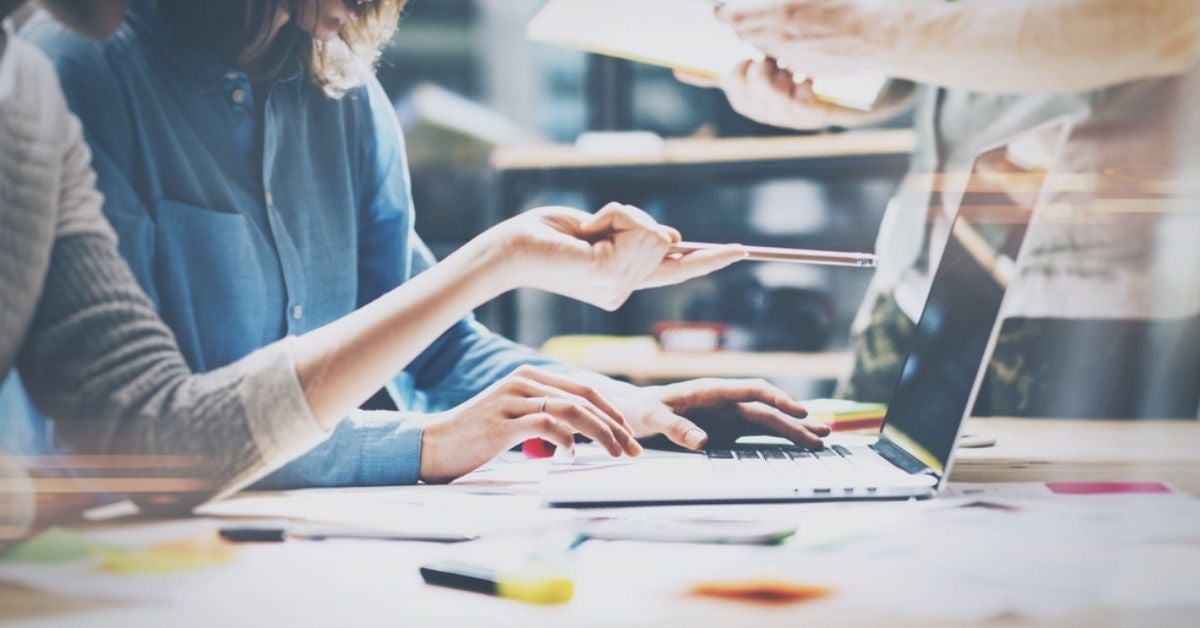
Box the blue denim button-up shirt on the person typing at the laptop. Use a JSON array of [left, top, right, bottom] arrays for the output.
[[23, 0, 545, 488]]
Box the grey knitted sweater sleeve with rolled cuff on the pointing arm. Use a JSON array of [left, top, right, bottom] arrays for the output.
[[18, 88, 328, 507]]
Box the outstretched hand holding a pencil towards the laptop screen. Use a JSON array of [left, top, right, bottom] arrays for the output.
[[490, 203, 746, 310]]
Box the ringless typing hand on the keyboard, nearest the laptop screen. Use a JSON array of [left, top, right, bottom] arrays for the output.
[[623, 379, 830, 449]]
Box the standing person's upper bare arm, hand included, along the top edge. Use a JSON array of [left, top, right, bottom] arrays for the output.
[[719, 0, 1200, 94]]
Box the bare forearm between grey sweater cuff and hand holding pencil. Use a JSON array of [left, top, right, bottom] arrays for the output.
[[295, 235, 516, 425]]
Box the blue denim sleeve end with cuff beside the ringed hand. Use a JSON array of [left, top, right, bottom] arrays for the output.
[[253, 411, 422, 490]]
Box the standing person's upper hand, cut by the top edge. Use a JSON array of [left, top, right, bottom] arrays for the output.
[[716, 0, 892, 78]]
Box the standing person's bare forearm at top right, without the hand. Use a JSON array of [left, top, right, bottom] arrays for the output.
[[870, 0, 1200, 94]]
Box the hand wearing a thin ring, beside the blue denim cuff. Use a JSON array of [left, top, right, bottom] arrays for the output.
[[420, 366, 642, 483]]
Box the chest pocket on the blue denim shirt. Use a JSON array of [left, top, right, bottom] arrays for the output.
[[148, 201, 283, 371]]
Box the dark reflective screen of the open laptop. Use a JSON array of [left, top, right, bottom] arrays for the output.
[[881, 125, 1066, 474]]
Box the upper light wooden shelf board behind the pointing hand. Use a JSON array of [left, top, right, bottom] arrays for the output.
[[492, 128, 917, 172]]
